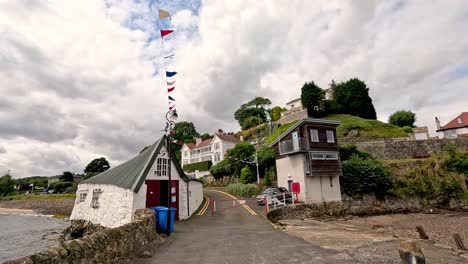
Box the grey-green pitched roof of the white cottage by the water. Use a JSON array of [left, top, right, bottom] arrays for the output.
[[80, 136, 201, 192]]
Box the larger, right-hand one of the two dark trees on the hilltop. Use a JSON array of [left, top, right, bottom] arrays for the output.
[[335, 78, 377, 119]]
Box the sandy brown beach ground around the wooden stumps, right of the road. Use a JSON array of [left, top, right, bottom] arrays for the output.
[[277, 212, 468, 263]]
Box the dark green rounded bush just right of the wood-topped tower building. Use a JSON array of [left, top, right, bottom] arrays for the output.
[[341, 155, 392, 198]]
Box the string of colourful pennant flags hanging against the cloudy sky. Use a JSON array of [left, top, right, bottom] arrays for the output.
[[158, 9, 177, 112]]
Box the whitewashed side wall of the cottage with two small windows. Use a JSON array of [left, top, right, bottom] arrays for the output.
[[70, 183, 134, 227]]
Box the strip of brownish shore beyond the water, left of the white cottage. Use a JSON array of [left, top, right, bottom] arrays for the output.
[[0, 199, 75, 217]]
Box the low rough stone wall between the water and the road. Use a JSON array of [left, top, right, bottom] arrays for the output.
[[5, 209, 162, 264]]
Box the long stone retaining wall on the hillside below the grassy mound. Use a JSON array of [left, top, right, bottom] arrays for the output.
[[338, 138, 468, 159]]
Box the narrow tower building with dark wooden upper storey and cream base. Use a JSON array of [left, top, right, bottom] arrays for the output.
[[271, 118, 342, 203]]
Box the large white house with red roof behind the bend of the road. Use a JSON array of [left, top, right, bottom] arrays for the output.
[[181, 131, 240, 166]]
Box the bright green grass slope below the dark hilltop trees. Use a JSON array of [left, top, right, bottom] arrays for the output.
[[323, 114, 408, 137]]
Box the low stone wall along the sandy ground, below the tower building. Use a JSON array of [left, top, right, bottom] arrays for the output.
[[268, 195, 468, 222]]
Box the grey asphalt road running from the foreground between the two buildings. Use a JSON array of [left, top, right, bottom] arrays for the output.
[[143, 191, 354, 264]]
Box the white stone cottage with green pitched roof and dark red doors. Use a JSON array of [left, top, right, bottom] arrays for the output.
[[70, 136, 203, 227]]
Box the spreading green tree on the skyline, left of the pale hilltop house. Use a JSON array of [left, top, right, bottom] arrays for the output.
[[234, 97, 271, 127]]
